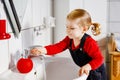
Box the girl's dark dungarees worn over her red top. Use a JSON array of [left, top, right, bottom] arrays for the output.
[[69, 34, 107, 80]]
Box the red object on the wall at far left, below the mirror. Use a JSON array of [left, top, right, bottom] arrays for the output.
[[0, 20, 11, 40]]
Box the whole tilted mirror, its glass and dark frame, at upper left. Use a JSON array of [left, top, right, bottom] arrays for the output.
[[1, 0, 27, 37]]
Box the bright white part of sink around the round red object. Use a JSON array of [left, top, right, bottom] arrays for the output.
[[0, 57, 46, 80]]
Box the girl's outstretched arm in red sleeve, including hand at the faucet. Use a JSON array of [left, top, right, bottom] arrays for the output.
[[31, 37, 70, 55]]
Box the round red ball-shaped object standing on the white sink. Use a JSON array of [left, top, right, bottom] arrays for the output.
[[17, 58, 33, 73]]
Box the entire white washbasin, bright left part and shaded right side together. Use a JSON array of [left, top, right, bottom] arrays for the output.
[[0, 56, 80, 80]]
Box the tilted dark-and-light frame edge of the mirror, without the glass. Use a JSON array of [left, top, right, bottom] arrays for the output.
[[2, 0, 21, 37]]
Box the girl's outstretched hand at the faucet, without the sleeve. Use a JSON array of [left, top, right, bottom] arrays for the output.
[[30, 47, 47, 55]]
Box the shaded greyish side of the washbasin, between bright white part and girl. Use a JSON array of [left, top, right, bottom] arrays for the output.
[[45, 57, 80, 80]]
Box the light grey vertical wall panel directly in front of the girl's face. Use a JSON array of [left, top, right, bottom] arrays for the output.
[[54, 0, 69, 42]]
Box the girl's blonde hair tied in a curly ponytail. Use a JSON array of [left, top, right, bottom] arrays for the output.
[[67, 9, 100, 36]]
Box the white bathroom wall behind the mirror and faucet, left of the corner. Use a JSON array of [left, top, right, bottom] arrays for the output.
[[0, 0, 52, 73]]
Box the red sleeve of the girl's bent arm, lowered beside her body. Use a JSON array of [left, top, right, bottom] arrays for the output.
[[84, 37, 104, 70]]
